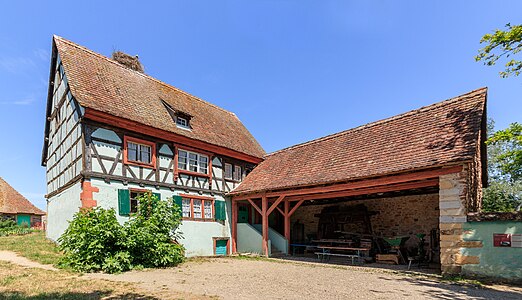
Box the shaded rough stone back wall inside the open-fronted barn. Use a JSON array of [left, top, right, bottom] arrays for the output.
[[292, 194, 439, 237]]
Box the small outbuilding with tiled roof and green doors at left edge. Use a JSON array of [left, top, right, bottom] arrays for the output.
[[0, 177, 45, 227]]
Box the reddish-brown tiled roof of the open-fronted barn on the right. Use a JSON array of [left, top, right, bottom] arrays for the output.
[[232, 88, 487, 194]]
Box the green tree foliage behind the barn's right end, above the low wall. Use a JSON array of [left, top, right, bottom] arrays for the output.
[[482, 120, 522, 212]]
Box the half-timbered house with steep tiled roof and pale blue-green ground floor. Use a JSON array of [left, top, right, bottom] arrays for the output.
[[42, 36, 265, 256]]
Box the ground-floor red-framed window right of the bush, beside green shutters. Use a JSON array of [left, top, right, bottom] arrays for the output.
[[181, 195, 215, 221]]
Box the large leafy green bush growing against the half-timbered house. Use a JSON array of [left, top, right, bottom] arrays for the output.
[[59, 193, 184, 273]]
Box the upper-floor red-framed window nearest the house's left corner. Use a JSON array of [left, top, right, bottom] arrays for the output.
[[123, 136, 156, 167]]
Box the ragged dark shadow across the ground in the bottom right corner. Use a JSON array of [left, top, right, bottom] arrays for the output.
[[379, 277, 522, 300]]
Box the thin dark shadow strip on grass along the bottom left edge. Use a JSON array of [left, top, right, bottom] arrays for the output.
[[0, 290, 160, 300]]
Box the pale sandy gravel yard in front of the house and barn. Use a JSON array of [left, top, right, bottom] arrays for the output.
[[88, 258, 522, 300]]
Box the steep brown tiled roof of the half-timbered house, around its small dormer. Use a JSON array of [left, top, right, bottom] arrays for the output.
[[54, 36, 265, 158]]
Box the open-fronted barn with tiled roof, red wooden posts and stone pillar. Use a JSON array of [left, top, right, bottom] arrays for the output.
[[230, 88, 487, 273]]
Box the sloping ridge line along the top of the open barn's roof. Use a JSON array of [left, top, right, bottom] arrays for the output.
[[265, 87, 488, 157]]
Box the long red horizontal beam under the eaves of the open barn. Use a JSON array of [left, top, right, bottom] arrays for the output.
[[232, 165, 462, 200]]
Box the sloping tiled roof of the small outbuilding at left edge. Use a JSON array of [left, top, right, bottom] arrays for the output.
[[0, 177, 45, 215]]
